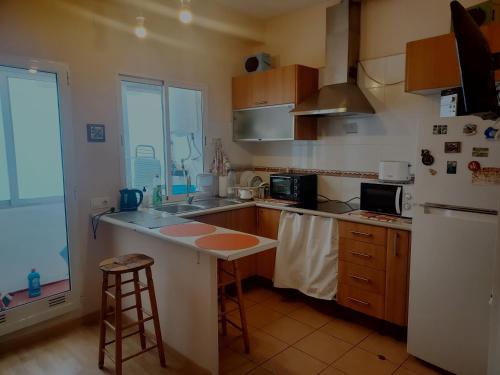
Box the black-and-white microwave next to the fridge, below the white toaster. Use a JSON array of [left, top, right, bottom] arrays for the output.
[[360, 182, 414, 218]]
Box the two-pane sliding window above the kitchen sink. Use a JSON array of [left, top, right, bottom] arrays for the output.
[[121, 77, 204, 197]]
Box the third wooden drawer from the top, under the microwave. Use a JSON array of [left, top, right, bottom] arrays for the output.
[[339, 261, 385, 295]]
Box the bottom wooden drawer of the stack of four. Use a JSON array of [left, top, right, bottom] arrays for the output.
[[337, 283, 384, 319]]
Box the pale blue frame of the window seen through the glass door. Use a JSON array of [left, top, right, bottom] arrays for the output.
[[0, 67, 64, 209]]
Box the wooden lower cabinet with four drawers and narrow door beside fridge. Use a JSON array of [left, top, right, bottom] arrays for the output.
[[337, 221, 411, 326]]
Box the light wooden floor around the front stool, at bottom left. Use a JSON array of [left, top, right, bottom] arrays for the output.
[[0, 324, 203, 375]]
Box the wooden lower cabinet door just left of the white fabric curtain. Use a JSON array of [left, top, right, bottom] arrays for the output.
[[256, 207, 281, 280]]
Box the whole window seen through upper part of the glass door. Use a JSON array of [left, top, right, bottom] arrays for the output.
[[0, 67, 64, 206]]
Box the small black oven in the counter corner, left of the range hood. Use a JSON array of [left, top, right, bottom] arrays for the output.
[[270, 173, 318, 203]]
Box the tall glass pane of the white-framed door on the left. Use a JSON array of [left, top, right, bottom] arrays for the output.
[[0, 66, 71, 312]]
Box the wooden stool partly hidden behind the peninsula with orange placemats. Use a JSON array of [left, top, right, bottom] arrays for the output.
[[217, 259, 250, 353]]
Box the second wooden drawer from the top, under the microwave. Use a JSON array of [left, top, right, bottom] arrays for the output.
[[339, 237, 386, 270]]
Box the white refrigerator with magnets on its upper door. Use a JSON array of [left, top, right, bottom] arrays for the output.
[[408, 117, 500, 375]]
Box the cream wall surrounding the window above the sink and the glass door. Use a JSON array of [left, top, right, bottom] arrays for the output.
[[0, 0, 260, 313]]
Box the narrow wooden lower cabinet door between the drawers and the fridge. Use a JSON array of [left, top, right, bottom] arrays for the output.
[[385, 229, 411, 326]]
